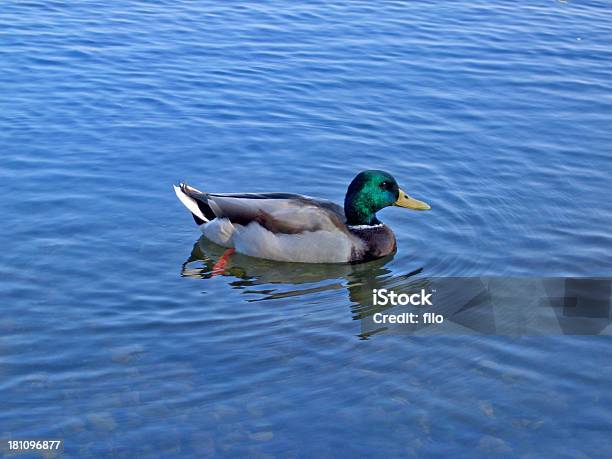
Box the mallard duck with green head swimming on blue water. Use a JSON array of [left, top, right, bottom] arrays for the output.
[[174, 170, 430, 263]]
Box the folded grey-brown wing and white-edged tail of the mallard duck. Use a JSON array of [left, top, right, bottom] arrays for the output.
[[175, 184, 347, 234]]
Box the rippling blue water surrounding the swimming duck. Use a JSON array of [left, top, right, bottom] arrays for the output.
[[0, 1, 612, 457]]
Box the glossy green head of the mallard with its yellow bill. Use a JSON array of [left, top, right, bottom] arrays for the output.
[[344, 170, 430, 225]]
